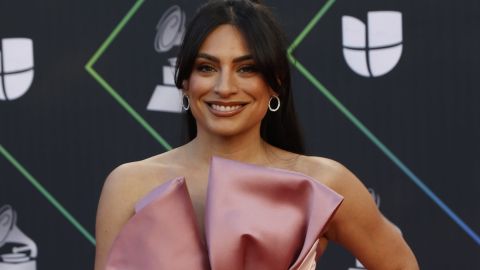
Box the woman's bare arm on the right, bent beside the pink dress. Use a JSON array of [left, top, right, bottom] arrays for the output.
[[326, 161, 419, 270]]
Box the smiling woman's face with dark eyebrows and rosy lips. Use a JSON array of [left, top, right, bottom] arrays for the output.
[[184, 24, 275, 136]]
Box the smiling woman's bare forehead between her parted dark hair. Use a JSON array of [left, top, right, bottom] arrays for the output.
[[199, 24, 250, 58]]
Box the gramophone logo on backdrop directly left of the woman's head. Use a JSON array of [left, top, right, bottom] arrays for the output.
[[147, 6, 186, 113]]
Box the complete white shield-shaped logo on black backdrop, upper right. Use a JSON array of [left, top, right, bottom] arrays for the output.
[[342, 11, 403, 77]]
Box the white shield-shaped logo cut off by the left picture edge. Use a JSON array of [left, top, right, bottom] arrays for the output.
[[0, 38, 33, 100]]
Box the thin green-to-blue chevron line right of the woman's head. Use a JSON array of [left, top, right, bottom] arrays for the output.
[[287, 0, 480, 245]]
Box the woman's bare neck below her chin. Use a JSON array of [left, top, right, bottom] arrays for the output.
[[189, 126, 268, 165]]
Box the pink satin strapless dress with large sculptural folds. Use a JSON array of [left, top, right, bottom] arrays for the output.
[[106, 157, 343, 270]]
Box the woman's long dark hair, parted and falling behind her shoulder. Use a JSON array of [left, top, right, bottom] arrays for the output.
[[175, 0, 304, 154]]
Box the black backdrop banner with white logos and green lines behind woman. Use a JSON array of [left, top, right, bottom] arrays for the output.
[[0, 0, 480, 270]]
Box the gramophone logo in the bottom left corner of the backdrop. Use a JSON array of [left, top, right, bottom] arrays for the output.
[[0, 205, 38, 270]]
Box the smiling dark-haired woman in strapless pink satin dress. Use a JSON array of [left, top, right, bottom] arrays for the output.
[[95, 1, 418, 270]]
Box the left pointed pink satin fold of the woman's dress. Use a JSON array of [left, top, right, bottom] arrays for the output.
[[106, 178, 210, 270]]
